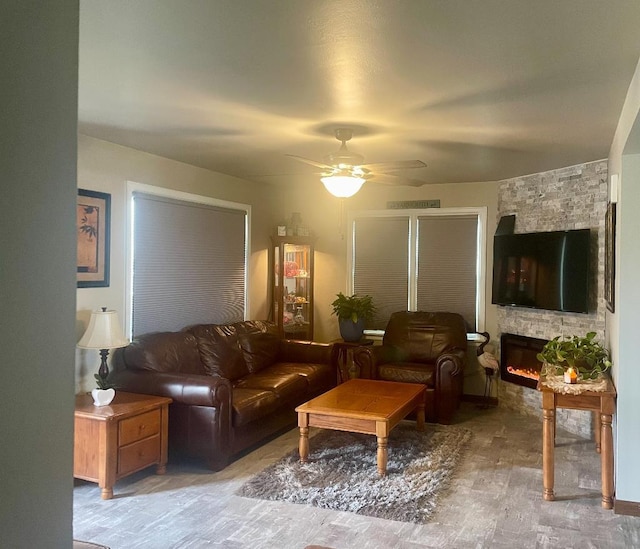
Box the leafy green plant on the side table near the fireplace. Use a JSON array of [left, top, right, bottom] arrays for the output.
[[537, 332, 611, 379]]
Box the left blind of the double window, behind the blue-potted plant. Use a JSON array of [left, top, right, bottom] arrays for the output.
[[353, 217, 409, 330]]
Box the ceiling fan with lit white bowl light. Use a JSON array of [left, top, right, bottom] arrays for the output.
[[287, 128, 426, 198]]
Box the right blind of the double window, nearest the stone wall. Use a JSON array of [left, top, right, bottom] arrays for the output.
[[416, 216, 478, 331]]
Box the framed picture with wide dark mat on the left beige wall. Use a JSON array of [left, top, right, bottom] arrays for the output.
[[76, 189, 111, 288]]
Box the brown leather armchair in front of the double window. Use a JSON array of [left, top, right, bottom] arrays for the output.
[[361, 311, 467, 423]]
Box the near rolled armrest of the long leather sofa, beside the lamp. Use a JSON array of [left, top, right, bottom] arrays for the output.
[[110, 370, 231, 408]]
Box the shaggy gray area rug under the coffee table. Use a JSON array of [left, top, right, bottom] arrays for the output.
[[236, 422, 471, 523]]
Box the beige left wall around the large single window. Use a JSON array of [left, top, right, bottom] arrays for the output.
[[76, 135, 277, 392]]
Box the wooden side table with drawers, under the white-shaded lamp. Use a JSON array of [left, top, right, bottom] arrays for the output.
[[73, 391, 171, 499]]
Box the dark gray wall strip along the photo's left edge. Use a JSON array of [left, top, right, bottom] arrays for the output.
[[0, 0, 79, 549]]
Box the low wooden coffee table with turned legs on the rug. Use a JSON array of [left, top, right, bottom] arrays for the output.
[[296, 379, 425, 476]]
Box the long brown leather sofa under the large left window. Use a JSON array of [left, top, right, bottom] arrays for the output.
[[110, 320, 337, 470]]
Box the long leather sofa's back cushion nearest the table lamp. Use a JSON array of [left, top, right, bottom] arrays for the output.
[[116, 332, 204, 374]]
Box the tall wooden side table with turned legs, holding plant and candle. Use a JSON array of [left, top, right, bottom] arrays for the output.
[[538, 378, 616, 509]]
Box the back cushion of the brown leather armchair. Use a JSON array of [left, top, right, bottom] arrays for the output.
[[383, 311, 467, 363]]
